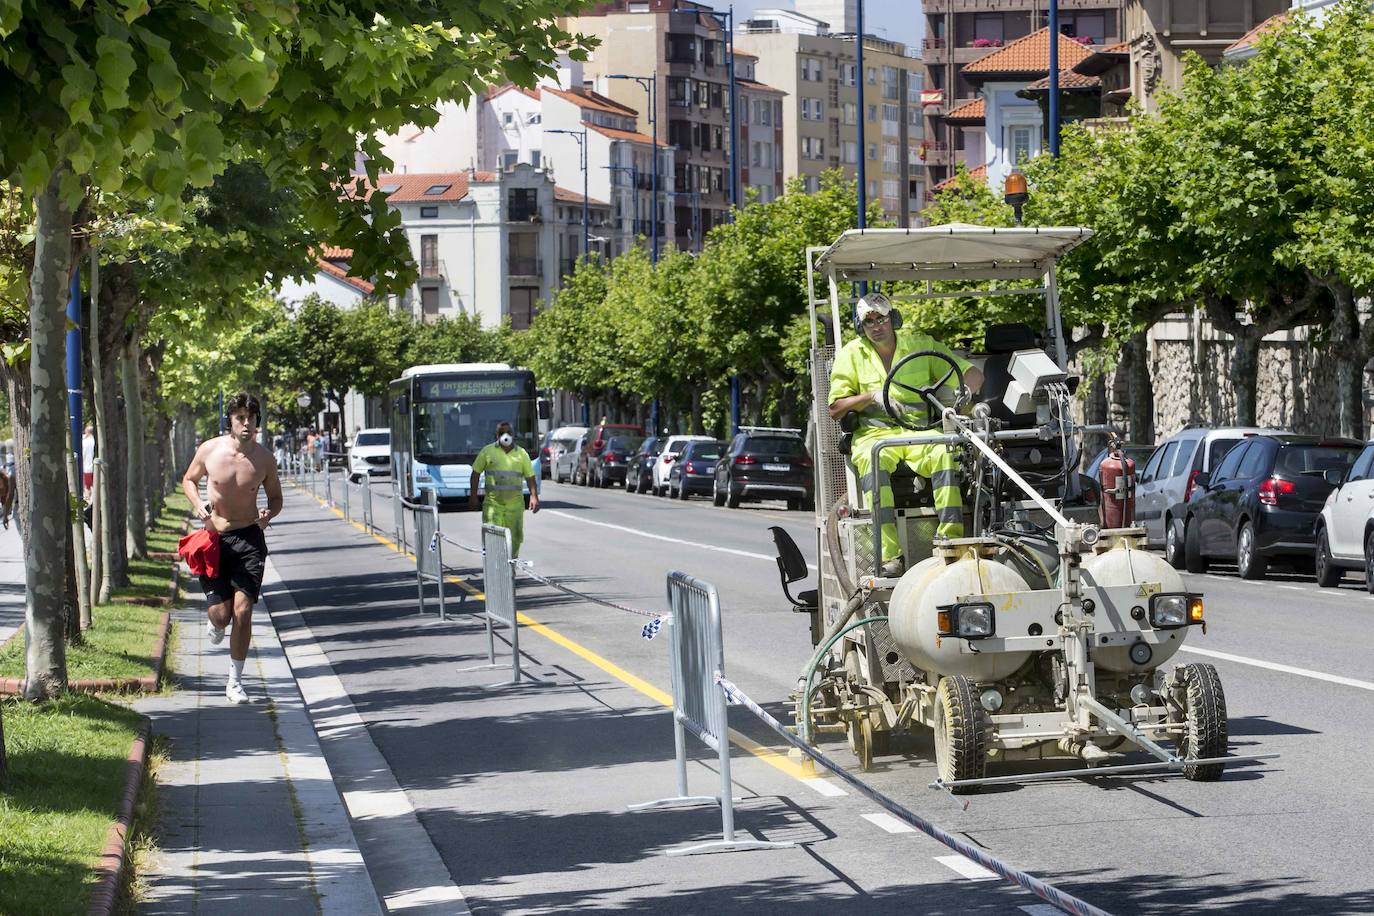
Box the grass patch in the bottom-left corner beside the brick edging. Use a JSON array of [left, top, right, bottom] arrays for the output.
[[0, 694, 140, 916]]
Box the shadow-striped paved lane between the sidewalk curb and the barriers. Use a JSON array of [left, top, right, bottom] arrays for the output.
[[272, 490, 1093, 913]]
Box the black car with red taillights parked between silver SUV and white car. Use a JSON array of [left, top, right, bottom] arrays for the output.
[[1183, 434, 1364, 580]]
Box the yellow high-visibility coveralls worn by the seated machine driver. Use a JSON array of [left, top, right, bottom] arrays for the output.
[[830, 328, 973, 563]]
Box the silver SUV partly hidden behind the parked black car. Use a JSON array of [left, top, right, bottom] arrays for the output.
[[1135, 426, 1282, 570]]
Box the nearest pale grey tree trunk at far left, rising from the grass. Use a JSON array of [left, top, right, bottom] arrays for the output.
[[23, 168, 71, 699]]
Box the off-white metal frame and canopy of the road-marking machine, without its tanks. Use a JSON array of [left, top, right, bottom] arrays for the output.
[[797, 224, 1272, 790]]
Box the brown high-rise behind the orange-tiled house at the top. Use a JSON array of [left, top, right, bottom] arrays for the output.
[[922, 0, 1126, 187]]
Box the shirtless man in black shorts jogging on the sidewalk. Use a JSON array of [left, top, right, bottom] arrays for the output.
[[181, 393, 282, 703]]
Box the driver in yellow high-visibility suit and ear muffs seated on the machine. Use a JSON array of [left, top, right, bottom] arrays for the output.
[[830, 293, 982, 575]]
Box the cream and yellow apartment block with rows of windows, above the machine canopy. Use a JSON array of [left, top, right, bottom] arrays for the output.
[[735, 10, 925, 225]]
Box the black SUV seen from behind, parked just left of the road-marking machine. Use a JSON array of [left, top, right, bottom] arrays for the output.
[[712, 428, 815, 509]]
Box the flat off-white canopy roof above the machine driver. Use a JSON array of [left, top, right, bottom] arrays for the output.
[[816, 222, 1092, 280]]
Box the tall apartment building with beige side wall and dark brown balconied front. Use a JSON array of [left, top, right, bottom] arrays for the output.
[[566, 0, 731, 250]]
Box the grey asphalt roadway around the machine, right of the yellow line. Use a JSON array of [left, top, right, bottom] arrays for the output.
[[292, 472, 1374, 916]]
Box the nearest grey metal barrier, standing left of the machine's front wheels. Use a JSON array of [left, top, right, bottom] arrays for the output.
[[629, 571, 793, 856]]
